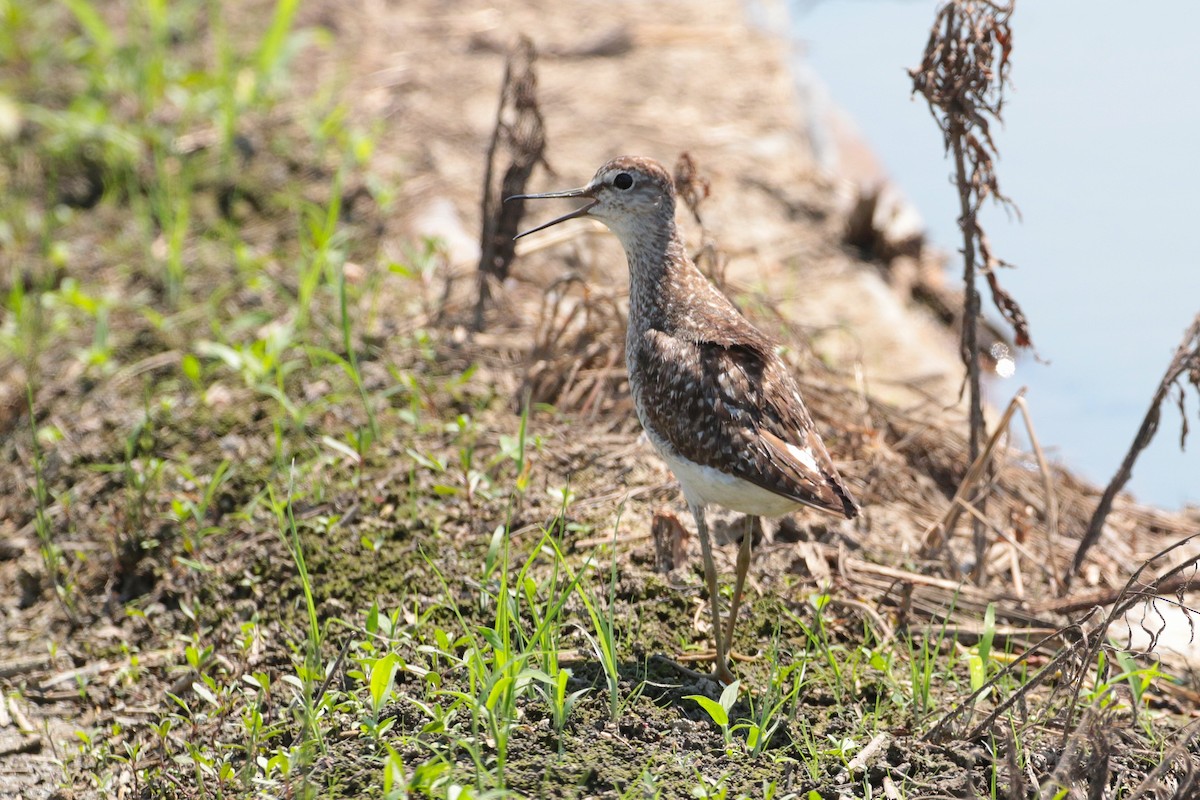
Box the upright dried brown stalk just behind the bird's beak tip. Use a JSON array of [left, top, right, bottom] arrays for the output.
[[475, 36, 546, 331]]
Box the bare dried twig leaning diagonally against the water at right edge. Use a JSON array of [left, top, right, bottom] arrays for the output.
[[1063, 314, 1200, 585]]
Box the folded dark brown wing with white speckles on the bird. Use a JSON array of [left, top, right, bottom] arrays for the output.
[[630, 324, 858, 518]]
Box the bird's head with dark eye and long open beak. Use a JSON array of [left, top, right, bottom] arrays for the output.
[[505, 156, 674, 249]]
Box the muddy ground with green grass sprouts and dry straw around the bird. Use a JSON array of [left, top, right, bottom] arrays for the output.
[[0, 0, 1200, 798]]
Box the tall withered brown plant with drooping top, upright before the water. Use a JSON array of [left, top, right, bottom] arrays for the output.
[[910, 0, 1032, 579]]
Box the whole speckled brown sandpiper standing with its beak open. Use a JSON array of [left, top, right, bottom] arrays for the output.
[[515, 156, 858, 682]]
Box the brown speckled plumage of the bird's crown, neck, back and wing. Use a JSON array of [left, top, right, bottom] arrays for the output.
[[585, 156, 858, 517]]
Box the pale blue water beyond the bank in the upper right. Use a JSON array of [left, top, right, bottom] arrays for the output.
[[791, 0, 1200, 507]]
